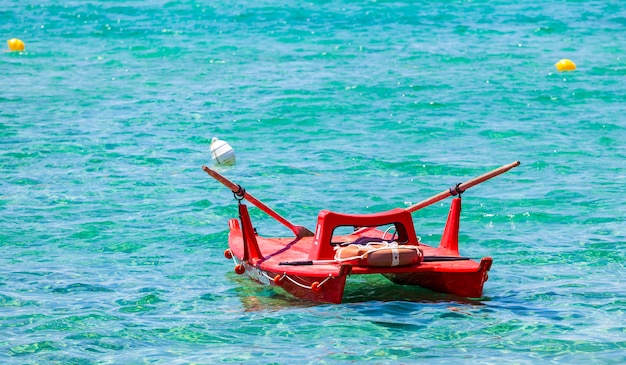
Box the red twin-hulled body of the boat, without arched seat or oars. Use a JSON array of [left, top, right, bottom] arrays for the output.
[[228, 198, 492, 303]]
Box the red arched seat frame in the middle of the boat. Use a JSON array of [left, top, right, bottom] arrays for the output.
[[309, 208, 418, 260]]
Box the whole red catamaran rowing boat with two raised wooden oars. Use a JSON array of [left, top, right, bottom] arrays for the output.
[[202, 161, 520, 303]]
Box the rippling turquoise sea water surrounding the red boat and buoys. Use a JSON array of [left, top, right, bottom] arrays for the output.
[[0, 0, 626, 364]]
